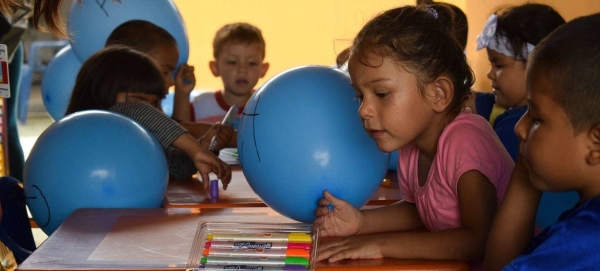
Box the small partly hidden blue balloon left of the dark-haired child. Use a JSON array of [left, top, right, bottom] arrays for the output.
[[41, 45, 81, 120]]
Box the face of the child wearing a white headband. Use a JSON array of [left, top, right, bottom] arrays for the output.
[[486, 48, 527, 108]]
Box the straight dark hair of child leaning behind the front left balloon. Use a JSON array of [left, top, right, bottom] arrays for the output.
[[66, 46, 166, 115]]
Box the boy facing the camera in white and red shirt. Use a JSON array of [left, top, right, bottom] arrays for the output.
[[185, 23, 269, 128]]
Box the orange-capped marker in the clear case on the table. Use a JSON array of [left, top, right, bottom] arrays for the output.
[[202, 248, 310, 259]]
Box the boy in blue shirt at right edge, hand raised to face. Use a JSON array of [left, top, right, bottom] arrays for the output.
[[486, 14, 600, 270]]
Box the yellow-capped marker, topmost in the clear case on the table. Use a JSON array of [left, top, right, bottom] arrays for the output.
[[206, 232, 312, 243]]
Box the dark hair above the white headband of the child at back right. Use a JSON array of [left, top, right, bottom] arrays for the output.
[[494, 4, 565, 59]]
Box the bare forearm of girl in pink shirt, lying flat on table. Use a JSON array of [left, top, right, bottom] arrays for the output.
[[317, 171, 497, 262]]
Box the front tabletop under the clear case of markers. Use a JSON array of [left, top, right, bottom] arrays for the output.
[[17, 207, 468, 271]]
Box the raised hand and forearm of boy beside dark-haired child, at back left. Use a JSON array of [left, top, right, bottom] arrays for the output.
[[173, 64, 196, 121]]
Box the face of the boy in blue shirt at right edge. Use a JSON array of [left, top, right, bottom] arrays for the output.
[[515, 72, 593, 199]]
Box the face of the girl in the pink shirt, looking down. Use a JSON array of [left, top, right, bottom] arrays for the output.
[[348, 54, 435, 152]]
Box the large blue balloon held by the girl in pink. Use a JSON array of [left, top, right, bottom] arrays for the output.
[[237, 66, 389, 223]]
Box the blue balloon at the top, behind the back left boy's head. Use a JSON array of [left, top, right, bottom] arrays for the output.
[[67, 0, 189, 64]]
